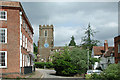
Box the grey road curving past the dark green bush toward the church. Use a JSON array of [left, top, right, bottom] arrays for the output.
[[37, 69, 84, 80]]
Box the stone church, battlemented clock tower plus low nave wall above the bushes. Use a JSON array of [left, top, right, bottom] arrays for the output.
[[37, 25, 74, 62]]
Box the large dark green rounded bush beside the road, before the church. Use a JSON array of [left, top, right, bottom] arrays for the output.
[[53, 47, 77, 76]]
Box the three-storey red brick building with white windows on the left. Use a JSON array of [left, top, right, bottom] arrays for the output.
[[0, 1, 33, 77]]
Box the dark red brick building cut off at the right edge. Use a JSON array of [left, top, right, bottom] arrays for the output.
[[114, 36, 120, 63]]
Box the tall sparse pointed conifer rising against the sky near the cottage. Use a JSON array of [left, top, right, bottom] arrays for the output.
[[82, 23, 100, 50]]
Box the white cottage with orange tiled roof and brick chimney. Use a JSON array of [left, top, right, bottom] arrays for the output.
[[92, 40, 115, 69]]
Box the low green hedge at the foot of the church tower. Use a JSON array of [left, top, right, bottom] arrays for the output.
[[35, 62, 53, 68]]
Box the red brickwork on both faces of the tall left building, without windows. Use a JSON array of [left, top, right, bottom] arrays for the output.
[[0, 1, 33, 78]]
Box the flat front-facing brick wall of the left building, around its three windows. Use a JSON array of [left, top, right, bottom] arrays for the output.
[[0, 9, 20, 73]]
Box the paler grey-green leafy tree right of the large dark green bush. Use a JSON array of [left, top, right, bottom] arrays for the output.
[[70, 48, 88, 74]]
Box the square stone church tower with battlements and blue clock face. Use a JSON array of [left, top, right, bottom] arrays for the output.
[[37, 25, 54, 62]]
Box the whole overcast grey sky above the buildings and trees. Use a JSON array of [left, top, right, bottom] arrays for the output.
[[11, 2, 118, 46]]
